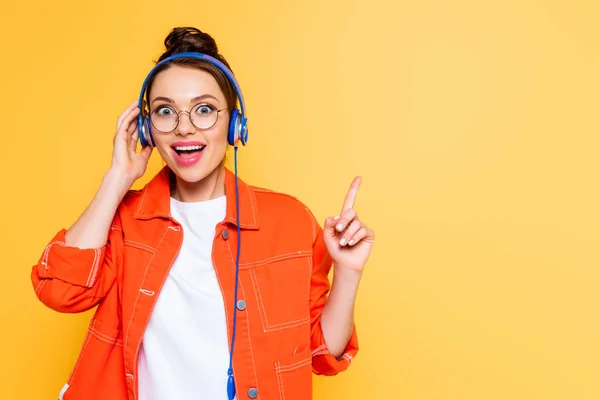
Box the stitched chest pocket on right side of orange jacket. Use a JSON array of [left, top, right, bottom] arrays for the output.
[[248, 252, 311, 332]]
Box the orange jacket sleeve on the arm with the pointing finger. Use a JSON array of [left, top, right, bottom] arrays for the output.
[[310, 209, 358, 376]]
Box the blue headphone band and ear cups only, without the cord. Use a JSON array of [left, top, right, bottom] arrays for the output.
[[138, 52, 248, 147]]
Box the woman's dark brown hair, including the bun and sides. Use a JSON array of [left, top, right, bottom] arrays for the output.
[[146, 27, 237, 112]]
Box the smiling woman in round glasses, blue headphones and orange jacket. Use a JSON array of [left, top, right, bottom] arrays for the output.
[[32, 28, 374, 400]]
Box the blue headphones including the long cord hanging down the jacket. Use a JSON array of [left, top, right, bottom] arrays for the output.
[[138, 52, 248, 400]]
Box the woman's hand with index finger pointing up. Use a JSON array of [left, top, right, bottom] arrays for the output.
[[323, 177, 375, 273]]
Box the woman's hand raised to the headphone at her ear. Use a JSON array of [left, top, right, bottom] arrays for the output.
[[110, 100, 152, 190]]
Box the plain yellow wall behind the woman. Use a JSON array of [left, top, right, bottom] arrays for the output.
[[0, 0, 600, 400]]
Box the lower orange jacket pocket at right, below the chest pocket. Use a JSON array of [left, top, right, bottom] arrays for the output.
[[275, 347, 312, 400]]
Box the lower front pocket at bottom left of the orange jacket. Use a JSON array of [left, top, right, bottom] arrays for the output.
[[63, 319, 126, 400]]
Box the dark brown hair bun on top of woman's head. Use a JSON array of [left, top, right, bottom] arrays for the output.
[[159, 27, 219, 61]]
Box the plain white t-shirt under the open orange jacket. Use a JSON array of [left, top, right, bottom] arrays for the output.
[[138, 196, 229, 400]]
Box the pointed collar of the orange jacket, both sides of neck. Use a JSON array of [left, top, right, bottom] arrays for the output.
[[135, 166, 258, 229]]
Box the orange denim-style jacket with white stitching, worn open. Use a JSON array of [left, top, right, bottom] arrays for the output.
[[31, 167, 358, 400]]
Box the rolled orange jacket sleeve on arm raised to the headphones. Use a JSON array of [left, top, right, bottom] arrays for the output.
[[31, 214, 123, 313]]
